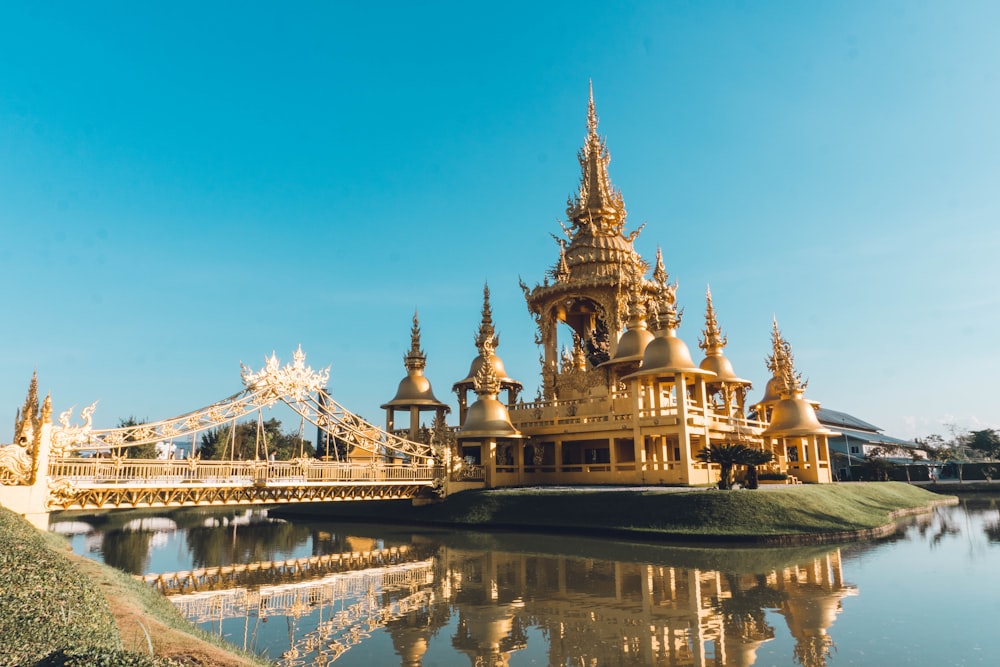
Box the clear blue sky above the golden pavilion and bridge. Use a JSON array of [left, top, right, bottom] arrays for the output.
[[0, 0, 1000, 442]]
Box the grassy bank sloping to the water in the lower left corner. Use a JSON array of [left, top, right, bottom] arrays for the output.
[[0, 508, 267, 667]]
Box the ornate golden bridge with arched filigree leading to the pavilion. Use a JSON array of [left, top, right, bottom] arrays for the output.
[[0, 348, 443, 523]]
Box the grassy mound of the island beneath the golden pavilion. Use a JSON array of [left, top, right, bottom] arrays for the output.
[[275, 482, 943, 543]]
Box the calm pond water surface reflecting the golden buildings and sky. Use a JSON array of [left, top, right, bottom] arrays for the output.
[[52, 498, 1000, 667]]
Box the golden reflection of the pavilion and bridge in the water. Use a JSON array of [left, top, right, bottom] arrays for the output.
[[131, 536, 856, 667]]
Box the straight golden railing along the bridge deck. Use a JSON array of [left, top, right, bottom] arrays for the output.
[[49, 458, 438, 485]]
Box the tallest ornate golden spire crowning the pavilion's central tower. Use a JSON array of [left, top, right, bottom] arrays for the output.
[[566, 82, 627, 236]]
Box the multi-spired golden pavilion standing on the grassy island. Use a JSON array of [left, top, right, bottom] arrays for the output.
[[383, 89, 837, 491]]
